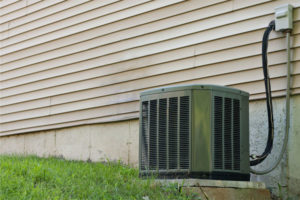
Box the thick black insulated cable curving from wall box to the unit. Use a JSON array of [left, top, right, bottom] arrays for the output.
[[250, 20, 275, 166]]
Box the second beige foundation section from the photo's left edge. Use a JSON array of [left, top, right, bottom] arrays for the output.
[[24, 131, 56, 157]]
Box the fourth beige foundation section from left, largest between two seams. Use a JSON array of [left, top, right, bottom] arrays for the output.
[[90, 121, 130, 164]]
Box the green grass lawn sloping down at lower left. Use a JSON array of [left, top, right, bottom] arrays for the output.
[[0, 156, 190, 200]]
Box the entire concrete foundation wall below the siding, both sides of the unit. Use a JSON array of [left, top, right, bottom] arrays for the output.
[[0, 95, 300, 196]]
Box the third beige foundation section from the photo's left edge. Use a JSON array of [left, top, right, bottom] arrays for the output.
[[55, 125, 90, 161]]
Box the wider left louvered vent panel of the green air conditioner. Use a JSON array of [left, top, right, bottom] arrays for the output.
[[141, 96, 190, 170]]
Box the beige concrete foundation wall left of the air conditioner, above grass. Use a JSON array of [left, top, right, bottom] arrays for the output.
[[0, 120, 139, 166]]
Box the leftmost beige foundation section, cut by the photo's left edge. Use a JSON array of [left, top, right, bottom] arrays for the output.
[[0, 135, 24, 155]]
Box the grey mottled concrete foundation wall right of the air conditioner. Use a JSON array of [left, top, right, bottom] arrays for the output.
[[249, 95, 300, 199]]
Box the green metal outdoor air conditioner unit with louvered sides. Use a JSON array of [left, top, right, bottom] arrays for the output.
[[139, 85, 250, 180]]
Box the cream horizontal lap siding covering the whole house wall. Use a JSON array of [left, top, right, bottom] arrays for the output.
[[0, 0, 300, 135]]
